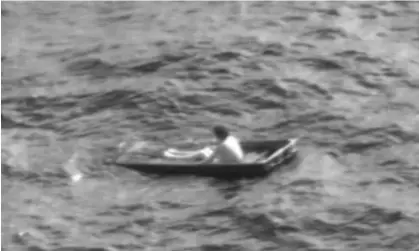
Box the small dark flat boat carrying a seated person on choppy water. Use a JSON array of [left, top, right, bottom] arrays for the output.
[[113, 138, 298, 179]]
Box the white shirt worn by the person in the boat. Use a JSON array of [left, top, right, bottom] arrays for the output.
[[214, 136, 244, 164]]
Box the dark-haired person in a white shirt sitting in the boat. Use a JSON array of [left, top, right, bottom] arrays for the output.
[[200, 125, 244, 164]]
